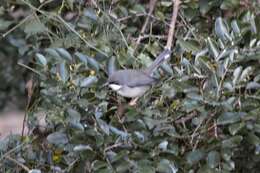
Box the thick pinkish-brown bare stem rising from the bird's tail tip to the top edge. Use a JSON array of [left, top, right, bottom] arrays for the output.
[[165, 0, 180, 49]]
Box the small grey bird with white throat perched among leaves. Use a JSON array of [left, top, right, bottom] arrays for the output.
[[107, 49, 171, 100]]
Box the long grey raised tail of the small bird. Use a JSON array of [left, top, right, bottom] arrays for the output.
[[145, 49, 171, 74]]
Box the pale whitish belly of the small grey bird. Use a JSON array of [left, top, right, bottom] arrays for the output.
[[117, 86, 150, 98]]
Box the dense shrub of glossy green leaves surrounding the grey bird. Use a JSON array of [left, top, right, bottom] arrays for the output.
[[0, 0, 260, 173]]
